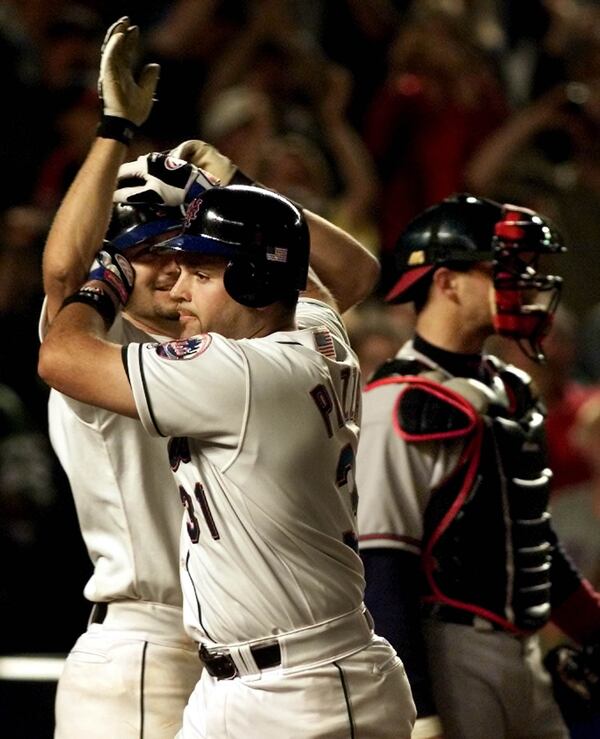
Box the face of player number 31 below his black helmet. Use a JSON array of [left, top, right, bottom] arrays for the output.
[[171, 254, 259, 339]]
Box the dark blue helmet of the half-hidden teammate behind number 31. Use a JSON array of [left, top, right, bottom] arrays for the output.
[[105, 203, 184, 251]]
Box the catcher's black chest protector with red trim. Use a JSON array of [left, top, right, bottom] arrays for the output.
[[374, 357, 552, 631]]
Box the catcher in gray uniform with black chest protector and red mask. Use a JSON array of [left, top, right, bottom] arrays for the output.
[[357, 195, 600, 739]]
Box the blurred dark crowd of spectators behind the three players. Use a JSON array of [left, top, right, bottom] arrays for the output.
[[0, 0, 600, 652]]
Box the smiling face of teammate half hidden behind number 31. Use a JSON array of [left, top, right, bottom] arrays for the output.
[[126, 251, 181, 338]]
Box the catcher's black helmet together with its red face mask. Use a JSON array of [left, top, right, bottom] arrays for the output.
[[386, 193, 565, 362]]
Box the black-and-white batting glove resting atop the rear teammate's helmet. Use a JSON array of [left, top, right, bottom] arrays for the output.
[[113, 152, 219, 206]]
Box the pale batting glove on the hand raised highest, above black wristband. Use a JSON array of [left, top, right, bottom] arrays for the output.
[[98, 16, 160, 126]]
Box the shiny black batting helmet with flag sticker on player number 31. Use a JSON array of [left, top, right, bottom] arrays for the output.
[[159, 185, 310, 308]]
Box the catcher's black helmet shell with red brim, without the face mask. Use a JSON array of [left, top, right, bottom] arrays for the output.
[[386, 193, 503, 303]]
